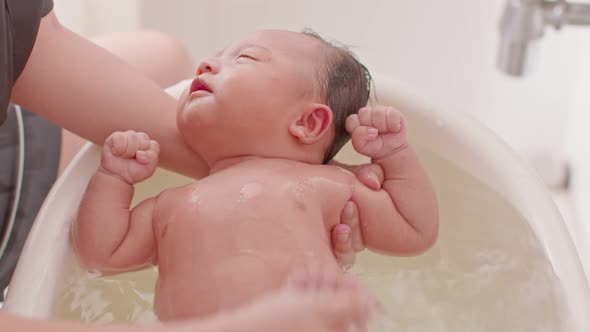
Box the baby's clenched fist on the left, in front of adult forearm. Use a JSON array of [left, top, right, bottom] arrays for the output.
[[101, 130, 160, 185]]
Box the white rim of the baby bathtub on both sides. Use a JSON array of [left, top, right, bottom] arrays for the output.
[[2, 75, 590, 331]]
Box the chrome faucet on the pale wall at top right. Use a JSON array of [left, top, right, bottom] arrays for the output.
[[498, 0, 590, 76]]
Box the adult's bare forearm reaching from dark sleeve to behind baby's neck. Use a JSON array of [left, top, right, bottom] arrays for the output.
[[11, 13, 207, 177]]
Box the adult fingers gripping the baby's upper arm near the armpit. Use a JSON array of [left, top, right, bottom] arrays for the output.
[[330, 160, 384, 268]]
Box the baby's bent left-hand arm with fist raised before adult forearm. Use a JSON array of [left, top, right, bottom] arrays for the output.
[[72, 131, 159, 272]]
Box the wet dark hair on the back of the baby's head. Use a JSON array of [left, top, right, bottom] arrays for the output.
[[302, 29, 372, 163]]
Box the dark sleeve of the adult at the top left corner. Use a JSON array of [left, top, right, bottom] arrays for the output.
[[0, 0, 53, 124]]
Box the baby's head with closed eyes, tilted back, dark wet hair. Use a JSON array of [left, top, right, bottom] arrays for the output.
[[178, 31, 370, 164]]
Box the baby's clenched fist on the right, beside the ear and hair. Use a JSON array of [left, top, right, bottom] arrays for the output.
[[346, 106, 408, 159]]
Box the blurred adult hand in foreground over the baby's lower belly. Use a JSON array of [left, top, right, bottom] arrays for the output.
[[213, 270, 383, 332]]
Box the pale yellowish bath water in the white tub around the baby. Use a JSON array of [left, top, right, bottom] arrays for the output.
[[48, 151, 568, 332]]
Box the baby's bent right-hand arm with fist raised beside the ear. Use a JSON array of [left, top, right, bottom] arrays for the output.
[[346, 107, 438, 255]]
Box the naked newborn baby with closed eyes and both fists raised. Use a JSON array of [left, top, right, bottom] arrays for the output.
[[73, 31, 438, 320]]
